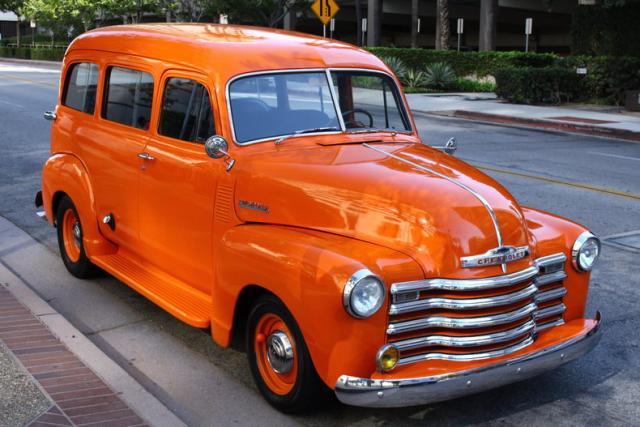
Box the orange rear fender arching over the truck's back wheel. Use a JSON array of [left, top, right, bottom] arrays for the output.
[[42, 153, 116, 258]]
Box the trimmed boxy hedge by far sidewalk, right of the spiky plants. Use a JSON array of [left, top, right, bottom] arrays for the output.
[[495, 67, 584, 104]]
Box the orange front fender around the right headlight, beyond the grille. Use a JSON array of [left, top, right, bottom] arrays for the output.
[[522, 207, 591, 321]]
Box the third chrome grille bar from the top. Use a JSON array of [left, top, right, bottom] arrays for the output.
[[387, 302, 540, 335]]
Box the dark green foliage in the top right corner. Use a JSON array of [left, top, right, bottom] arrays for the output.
[[571, 3, 640, 55]]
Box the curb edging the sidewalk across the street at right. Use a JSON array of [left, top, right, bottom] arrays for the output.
[[438, 110, 640, 142]]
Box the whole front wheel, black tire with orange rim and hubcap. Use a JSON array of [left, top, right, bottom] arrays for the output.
[[245, 295, 330, 413]]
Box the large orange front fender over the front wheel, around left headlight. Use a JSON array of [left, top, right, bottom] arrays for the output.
[[212, 224, 423, 388]]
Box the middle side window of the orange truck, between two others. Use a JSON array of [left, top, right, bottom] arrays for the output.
[[102, 67, 153, 129]]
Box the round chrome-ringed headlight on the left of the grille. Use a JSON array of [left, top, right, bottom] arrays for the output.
[[342, 269, 384, 318]]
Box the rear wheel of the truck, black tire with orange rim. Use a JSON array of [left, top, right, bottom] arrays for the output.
[[56, 196, 97, 279]]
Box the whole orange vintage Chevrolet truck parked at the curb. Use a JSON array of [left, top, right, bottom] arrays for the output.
[[36, 24, 600, 412]]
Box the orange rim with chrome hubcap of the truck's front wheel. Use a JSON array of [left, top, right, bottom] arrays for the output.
[[254, 313, 298, 395]]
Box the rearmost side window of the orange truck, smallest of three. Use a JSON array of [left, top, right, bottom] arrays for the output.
[[62, 62, 98, 114]]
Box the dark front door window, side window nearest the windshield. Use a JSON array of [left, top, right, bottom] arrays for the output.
[[158, 77, 215, 142]]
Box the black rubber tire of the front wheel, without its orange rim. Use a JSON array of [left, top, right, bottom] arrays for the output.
[[245, 295, 331, 414]]
